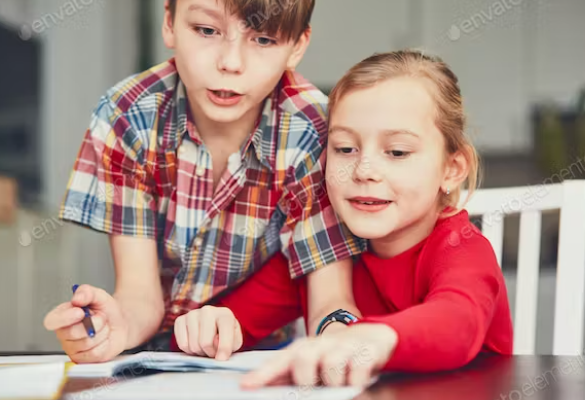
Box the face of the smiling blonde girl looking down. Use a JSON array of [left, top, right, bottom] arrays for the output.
[[327, 77, 464, 255]]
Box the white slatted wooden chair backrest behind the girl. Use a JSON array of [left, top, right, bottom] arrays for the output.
[[461, 180, 585, 355]]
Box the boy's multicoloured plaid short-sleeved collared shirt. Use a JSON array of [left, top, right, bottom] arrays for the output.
[[60, 59, 363, 331]]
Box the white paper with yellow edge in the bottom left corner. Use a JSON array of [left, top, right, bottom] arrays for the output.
[[0, 363, 65, 399]]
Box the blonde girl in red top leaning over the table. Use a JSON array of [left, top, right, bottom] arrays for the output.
[[175, 51, 513, 387]]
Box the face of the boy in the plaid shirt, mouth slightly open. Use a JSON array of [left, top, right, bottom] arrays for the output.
[[163, 0, 310, 123]]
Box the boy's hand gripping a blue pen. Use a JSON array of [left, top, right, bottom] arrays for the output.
[[44, 285, 128, 363]]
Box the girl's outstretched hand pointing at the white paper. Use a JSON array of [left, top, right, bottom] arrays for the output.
[[241, 324, 397, 389]]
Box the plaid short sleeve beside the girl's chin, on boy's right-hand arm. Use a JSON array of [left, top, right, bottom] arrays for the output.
[[281, 129, 365, 278]]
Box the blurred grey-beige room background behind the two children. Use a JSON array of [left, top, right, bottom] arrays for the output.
[[0, 0, 585, 353]]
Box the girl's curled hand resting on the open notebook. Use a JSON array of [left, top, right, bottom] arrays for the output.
[[175, 306, 244, 360]]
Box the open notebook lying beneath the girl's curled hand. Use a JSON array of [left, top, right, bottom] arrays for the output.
[[68, 350, 280, 377]]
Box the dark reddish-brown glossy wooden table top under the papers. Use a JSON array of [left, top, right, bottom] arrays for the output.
[[0, 353, 585, 400]]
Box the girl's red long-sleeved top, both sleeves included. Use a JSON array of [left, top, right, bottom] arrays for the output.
[[169, 211, 513, 372]]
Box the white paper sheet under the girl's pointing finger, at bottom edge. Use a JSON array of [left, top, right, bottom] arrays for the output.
[[65, 371, 363, 400]]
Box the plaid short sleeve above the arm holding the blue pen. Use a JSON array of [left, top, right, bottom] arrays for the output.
[[59, 97, 156, 238]]
